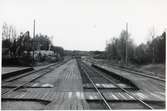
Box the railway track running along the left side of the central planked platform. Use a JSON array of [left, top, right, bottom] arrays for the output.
[[1, 60, 69, 96]]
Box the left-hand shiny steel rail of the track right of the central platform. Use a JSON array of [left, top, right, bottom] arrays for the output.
[[78, 61, 112, 110]]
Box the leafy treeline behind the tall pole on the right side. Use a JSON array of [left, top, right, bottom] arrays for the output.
[[105, 30, 166, 64]]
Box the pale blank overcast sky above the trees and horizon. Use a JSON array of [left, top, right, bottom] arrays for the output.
[[0, 0, 167, 50]]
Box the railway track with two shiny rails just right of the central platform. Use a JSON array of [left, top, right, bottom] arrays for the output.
[[78, 60, 153, 110]]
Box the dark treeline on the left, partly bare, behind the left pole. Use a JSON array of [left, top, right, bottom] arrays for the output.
[[2, 23, 64, 65]]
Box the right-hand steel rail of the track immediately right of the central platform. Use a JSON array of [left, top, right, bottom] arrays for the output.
[[85, 64, 153, 109]]
